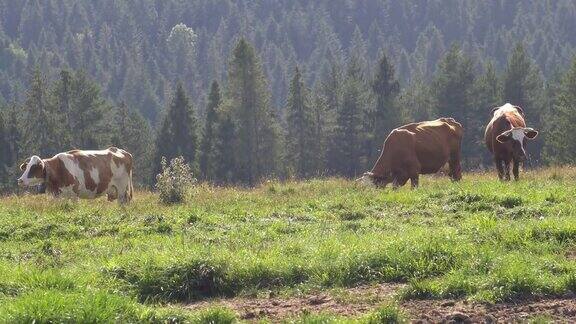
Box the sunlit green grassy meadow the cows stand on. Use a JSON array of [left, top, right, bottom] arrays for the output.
[[0, 168, 576, 323]]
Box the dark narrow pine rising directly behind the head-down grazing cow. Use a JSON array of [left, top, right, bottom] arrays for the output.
[[370, 54, 402, 160]]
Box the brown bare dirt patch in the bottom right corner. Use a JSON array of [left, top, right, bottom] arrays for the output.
[[400, 296, 576, 323]]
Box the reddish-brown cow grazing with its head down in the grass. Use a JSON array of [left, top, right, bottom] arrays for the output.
[[361, 118, 464, 189]]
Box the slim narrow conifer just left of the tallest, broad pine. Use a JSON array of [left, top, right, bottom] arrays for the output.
[[200, 81, 222, 180]]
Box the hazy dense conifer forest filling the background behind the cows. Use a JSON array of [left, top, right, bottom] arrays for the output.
[[0, 0, 576, 190]]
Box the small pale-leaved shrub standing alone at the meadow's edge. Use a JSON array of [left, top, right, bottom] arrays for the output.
[[156, 157, 196, 205]]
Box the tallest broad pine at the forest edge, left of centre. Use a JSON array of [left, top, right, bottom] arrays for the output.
[[228, 39, 280, 185]]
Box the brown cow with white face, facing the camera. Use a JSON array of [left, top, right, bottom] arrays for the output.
[[484, 103, 538, 181]]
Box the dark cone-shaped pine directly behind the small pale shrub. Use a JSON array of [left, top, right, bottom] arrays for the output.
[[154, 83, 198, 173]]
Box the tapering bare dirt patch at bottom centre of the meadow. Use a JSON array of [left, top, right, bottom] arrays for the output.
[[187, 284, 404, 320]]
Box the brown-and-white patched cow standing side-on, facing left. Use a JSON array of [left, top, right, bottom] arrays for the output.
[[18, 147, 133, 204]]
